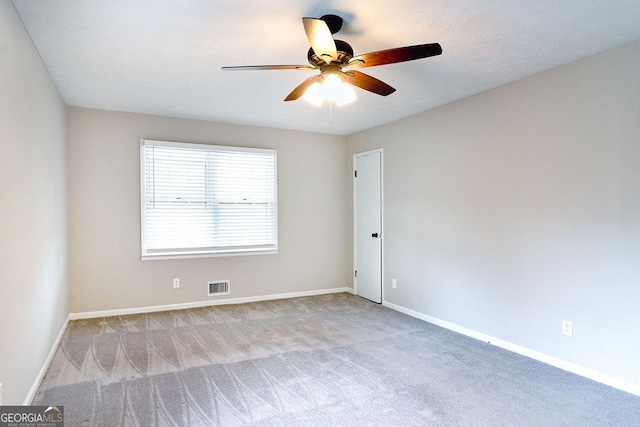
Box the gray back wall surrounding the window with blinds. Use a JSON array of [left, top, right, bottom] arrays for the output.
[[68, 108, 351, 312]]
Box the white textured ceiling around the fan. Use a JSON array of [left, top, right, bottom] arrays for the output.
[[13, 0, 640, 135]]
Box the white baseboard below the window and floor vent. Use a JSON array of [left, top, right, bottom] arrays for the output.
[[69, 287, 353, 320]]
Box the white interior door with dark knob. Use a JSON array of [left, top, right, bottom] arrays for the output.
[[353, 150, 382, 303]]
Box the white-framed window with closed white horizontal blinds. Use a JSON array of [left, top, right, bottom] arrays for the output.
[[140, 140, 278, 259]]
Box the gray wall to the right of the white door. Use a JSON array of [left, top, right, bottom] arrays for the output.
[[348, 42, 640, 384]]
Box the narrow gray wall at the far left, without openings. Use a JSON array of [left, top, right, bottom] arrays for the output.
[[0, 1, 67, 405]]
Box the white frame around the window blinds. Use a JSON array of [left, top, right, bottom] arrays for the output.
[[140, 139, 279, 261]]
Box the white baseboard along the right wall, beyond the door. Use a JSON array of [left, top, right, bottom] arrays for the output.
[[382, 301, 640, 396]]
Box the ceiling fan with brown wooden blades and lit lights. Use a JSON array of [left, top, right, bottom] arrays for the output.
[[222, 15, 442, 101]]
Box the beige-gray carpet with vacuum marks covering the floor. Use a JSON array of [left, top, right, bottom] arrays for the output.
[[33, 294, 640, 426]]
